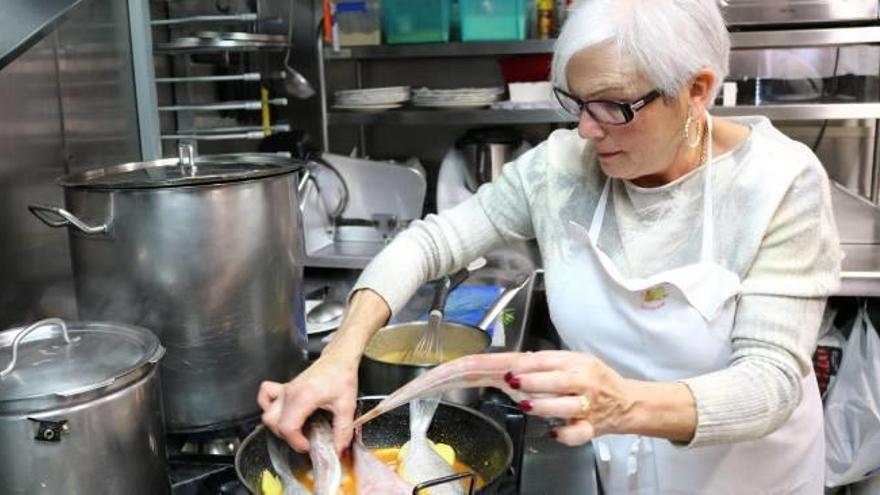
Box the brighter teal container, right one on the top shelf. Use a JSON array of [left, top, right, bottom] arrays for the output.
[[458, 0, 526, 41]]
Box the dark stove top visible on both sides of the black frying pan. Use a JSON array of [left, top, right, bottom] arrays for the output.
[[168, 396, 526, 495]]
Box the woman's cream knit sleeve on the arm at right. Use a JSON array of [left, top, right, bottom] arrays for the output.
[[683, 154, 842, 446]]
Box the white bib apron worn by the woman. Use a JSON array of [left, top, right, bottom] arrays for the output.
[[546, 114, 825, 495]]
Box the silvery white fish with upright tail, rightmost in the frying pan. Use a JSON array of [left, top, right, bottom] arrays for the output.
[[398, 395, 465, 495]]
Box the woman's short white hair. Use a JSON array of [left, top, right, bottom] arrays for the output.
[[550, 0, 730, 101]]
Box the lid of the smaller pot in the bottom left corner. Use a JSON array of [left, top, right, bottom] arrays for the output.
[[0, 318, 164, 412]]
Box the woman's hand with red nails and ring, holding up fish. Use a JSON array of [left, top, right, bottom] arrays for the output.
[[504, 351, 633, 446]]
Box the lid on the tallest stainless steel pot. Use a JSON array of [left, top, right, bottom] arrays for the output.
[[58, 153, 303, 189]]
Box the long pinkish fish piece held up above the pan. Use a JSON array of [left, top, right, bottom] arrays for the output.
[[352, 353, 536, 428]]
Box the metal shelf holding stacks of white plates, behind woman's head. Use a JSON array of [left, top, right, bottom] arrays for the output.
[[328, 103, 880, 125]]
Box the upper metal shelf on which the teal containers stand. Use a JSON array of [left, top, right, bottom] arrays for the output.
[[324, 26, 880, 60]]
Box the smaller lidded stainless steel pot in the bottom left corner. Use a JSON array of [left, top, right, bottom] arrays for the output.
[[0, 318, 171, 495]]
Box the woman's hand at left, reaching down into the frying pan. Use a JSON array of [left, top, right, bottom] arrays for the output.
[[257, 355, 358, 452]]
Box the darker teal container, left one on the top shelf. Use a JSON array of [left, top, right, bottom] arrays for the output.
[[382, 0, 452, 44]]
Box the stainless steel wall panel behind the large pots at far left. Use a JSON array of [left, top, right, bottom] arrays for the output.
[[0, 0, 140, 329]]
